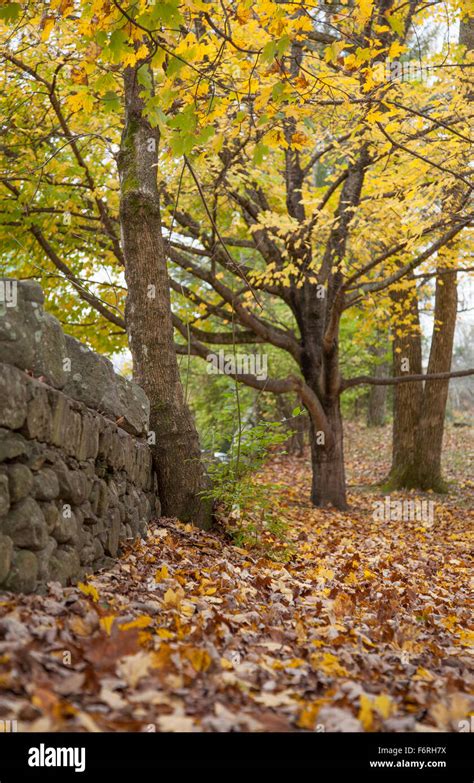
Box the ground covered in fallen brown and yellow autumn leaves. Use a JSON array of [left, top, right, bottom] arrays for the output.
[[0, 424, 474, 732]]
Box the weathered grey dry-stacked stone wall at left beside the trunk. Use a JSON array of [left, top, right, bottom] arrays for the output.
[[0, 280, 160, 592]]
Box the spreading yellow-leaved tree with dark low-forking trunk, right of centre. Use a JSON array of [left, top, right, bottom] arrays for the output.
[[163, 4, 471, 508]]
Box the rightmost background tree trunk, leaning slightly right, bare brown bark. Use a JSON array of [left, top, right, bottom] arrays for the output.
[[415, 274, 457, 492]]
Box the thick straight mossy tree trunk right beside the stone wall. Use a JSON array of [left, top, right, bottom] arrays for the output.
[[118, 68, 210, 526]]
